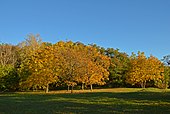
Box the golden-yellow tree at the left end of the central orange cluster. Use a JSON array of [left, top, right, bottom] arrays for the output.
[[22, 44, 60, 92]]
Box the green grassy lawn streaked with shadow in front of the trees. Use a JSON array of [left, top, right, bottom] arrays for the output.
[[0, 88, 170, 114]]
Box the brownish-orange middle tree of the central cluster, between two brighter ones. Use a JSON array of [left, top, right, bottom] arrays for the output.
[[55, 41, 83, 92]]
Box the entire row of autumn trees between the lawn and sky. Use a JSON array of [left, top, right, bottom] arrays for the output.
[[0, 34, 170, 92]]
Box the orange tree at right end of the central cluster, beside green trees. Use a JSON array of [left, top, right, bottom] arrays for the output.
[[75, 45, 110, 90]]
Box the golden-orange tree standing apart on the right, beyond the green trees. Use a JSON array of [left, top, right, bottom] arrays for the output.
[[126, 52, 164, 88]]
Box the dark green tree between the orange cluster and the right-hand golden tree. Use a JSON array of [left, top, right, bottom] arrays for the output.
[[105, 48, 130, 87]]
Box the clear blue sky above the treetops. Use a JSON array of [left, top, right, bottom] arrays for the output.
[[0, 0, 170, 59]]
